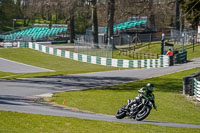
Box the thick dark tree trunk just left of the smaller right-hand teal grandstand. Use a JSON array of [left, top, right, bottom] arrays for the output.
[[107, 0, 115, 48]]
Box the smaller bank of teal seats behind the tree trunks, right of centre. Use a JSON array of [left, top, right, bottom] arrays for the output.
[[104, 20, 147, 32]]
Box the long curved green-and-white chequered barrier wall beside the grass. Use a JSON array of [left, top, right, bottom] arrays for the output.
[[29, 42, 169, 68]]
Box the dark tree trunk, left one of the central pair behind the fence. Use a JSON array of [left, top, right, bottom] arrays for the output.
[[92, 0, 99, 44]]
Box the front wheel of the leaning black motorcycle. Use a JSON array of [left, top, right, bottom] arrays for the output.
[[135, 106, 151, 121]]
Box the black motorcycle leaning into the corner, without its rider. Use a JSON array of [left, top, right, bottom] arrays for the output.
[[116, 98, 156, 121]]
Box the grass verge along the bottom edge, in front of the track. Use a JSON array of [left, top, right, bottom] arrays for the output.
[[0, 111, 200, 133]]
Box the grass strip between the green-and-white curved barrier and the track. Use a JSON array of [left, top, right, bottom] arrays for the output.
[[0, 48, 117, 78]]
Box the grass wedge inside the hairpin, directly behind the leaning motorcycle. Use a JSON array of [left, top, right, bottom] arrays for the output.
[[51, 68, 200, 124]]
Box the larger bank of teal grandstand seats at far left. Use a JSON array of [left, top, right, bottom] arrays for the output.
[[0, 27, 67, 40]]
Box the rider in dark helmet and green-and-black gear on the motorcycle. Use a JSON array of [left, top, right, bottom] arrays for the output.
[[127, 83, 157, 110]]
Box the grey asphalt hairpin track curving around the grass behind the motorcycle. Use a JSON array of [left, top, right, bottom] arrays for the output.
[[0, 58, 200, 128]]
